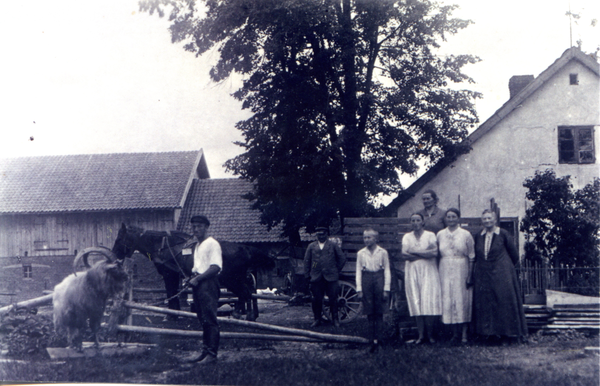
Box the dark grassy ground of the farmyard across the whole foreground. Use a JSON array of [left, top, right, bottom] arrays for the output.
[[0, 300, 600, 386]]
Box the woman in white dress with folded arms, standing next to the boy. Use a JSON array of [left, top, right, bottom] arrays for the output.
[[402, 213, 442, 344]]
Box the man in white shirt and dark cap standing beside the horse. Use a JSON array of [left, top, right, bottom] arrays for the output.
[[184, 216, 223, 364]]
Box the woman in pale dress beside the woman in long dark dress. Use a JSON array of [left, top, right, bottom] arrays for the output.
[[437, 208, 475, 344]]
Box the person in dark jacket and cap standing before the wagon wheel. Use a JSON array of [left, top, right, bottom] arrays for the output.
[[304, 227, 346, 327]]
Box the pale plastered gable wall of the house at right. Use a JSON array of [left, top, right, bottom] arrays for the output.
[[398, 60, 600, 245]]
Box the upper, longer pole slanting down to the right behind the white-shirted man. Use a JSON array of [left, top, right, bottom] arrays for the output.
[[124, 302, 369, 343]]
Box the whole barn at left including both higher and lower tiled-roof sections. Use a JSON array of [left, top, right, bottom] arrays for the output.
[[0, 150, 310, 304]]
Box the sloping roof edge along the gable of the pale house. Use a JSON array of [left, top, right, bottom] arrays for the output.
[[385, 47, 600, 216]]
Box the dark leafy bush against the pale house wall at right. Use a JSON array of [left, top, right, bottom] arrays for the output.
[[521, 169, 600, 270]]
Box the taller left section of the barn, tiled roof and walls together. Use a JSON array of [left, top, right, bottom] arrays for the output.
[[0, 150, 209, 304]]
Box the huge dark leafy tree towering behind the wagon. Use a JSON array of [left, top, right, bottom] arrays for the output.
[[141, 0, 479, 241]]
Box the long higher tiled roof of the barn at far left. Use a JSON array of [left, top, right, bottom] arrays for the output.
[[0, 150, 208, 214]]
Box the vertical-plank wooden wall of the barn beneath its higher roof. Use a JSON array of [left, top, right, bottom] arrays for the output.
[[0, 210, 175, 257]]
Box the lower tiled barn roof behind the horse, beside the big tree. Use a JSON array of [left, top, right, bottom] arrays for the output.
[[177, 178, 285, 243]]
